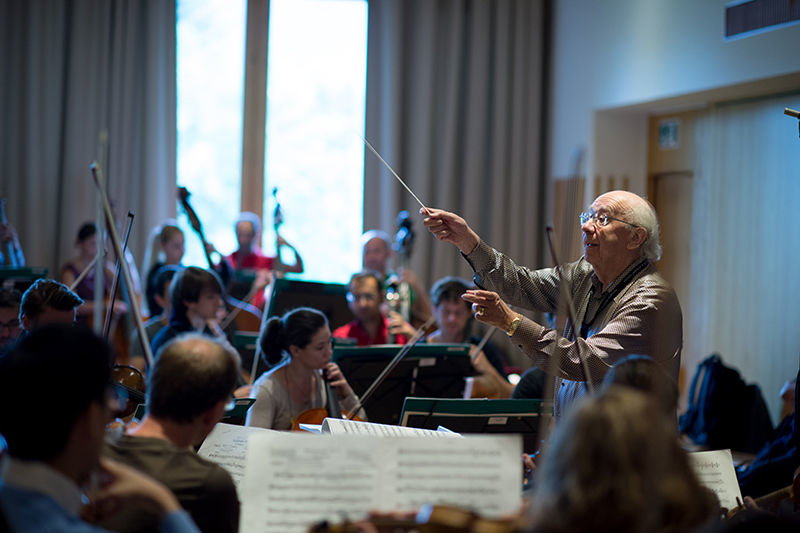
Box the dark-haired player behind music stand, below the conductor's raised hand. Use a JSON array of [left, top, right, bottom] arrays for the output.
[[427, 276, 514, 398]]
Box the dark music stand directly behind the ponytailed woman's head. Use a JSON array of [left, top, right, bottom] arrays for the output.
[[267, 278, 353, 330]]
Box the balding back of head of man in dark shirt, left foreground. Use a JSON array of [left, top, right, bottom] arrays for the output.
[[147, 333, 240, 423]]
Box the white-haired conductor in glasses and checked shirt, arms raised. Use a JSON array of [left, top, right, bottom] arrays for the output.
[[422, 191, 682, 417]]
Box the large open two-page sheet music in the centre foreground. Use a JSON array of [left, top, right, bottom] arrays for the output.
[[240, 432, 522, 533]]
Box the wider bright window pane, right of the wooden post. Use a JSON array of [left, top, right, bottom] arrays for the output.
[[264, 0, 367, 282]]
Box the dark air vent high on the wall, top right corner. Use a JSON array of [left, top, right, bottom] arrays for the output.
[[725, 0, 800, 39]]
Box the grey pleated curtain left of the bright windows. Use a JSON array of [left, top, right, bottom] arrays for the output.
[[0, 0, 176, 276]]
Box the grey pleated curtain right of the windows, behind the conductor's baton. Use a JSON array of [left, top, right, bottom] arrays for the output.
[[364, 0, 546, 286]]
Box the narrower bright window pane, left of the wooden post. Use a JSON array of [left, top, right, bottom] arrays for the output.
[[177, 0, 246, 266]]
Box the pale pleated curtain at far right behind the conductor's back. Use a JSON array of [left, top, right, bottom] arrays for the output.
[[684, 95, 800, 415]]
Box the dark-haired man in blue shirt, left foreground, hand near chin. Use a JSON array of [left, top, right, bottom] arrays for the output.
[[0, 324, 198, 533]]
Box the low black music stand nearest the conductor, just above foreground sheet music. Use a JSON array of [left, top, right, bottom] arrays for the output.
[[400, 398, 552, 453]]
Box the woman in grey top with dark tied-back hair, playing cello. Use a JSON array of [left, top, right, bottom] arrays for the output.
[[246, 307, 365, 430]]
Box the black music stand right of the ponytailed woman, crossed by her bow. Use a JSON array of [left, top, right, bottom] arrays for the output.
[[333, 344, 474, 424]]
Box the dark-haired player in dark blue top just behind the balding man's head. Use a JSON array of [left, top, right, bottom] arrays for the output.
[[150, 267, 228, 353]]
